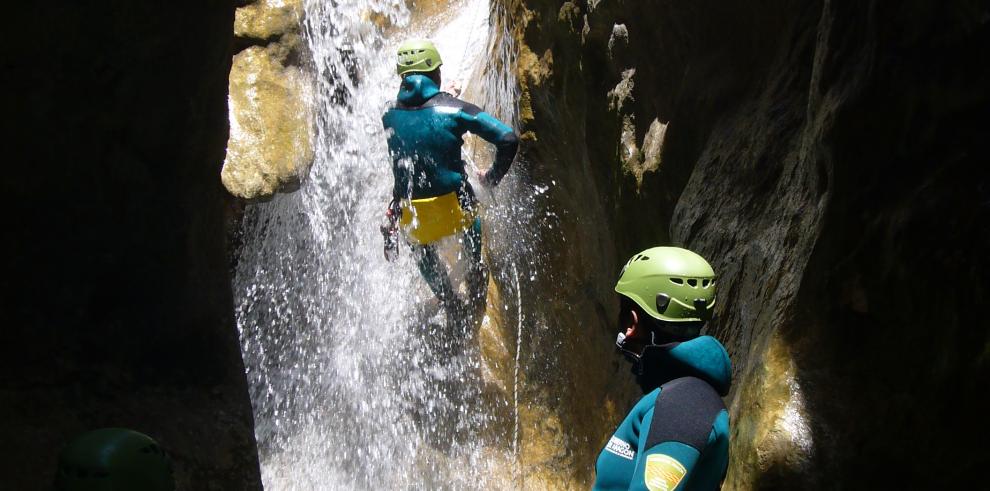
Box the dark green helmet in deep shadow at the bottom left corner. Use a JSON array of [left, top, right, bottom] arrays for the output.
[[55, 428, 175, 491]]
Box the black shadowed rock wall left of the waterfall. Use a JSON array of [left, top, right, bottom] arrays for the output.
[[0, 1, 260, 490]]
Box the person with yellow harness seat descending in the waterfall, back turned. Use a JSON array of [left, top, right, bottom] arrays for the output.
[[382, 40, 519, 316]]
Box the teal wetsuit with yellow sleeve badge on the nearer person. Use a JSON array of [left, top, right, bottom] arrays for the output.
[[594, 336, 732, 491]]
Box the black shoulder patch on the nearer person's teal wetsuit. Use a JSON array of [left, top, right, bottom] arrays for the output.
[[646, 377, 725, 453]]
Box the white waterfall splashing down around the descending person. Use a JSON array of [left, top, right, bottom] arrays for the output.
[[235, 0, 553, 489]]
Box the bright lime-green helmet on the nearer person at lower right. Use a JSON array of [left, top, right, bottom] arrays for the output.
[[615, 247, 715, 322]]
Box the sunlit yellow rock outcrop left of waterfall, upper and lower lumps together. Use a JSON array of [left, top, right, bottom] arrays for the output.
[[221, 0, 313, 200]]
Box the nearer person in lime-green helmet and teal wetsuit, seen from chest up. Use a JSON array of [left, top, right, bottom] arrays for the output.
[[594, 247, 732, 491]]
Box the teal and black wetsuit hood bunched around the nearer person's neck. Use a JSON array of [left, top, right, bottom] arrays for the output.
[[633, 336, 732, 396]]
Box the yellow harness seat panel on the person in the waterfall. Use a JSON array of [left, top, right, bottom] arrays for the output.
[[399, 192, 475, 245]]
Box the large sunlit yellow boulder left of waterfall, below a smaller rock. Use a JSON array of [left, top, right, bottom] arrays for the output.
[[221, 43, 313, 199]]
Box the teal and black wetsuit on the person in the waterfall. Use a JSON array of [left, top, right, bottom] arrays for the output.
[[382, 73, 519, 303]]
